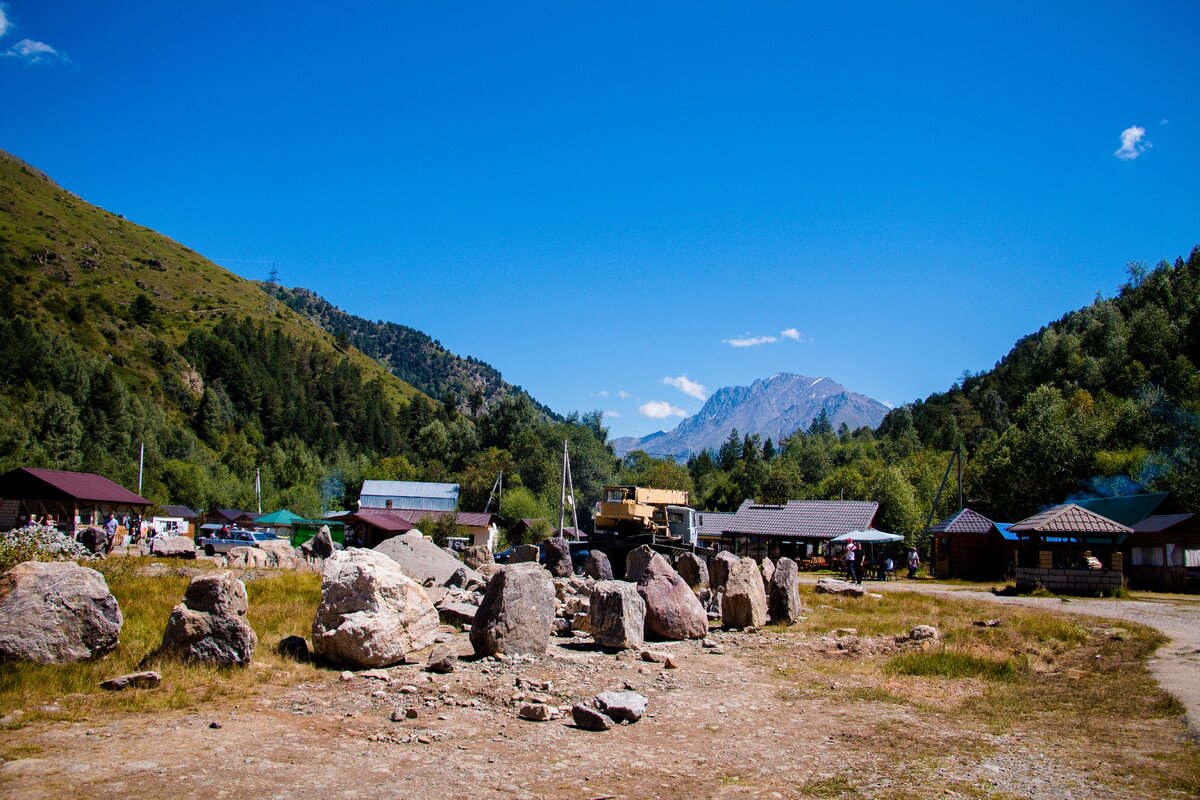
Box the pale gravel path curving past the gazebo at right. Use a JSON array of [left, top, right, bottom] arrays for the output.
[[800, 576, 1200, 741]]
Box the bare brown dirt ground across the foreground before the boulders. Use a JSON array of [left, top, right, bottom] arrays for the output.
[[0, 587, 1200, 800]]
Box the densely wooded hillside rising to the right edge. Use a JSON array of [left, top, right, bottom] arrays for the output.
[[652, 248, 1200, 535]]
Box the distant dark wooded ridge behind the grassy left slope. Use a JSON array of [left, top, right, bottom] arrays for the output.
[[262, 284, 554, 417]]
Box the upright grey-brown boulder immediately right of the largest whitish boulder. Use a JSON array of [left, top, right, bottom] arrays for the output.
[[470, 564, 554, 656]]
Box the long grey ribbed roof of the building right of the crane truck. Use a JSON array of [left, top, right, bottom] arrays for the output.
[[722, 500, 880, 539]]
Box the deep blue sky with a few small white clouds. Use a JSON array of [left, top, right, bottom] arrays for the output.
[[0, 0, 1200, 435]]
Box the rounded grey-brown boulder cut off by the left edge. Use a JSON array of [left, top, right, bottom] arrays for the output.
[[0, 561, 124, 664]]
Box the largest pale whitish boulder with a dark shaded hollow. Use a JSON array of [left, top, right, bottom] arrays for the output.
[[312, 548, 438, 668]]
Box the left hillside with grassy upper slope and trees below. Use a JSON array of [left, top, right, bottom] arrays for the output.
[[0, 148, 617, 532]]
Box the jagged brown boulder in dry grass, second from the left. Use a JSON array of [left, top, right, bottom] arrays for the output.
[[160, 572, 258, 667]]
